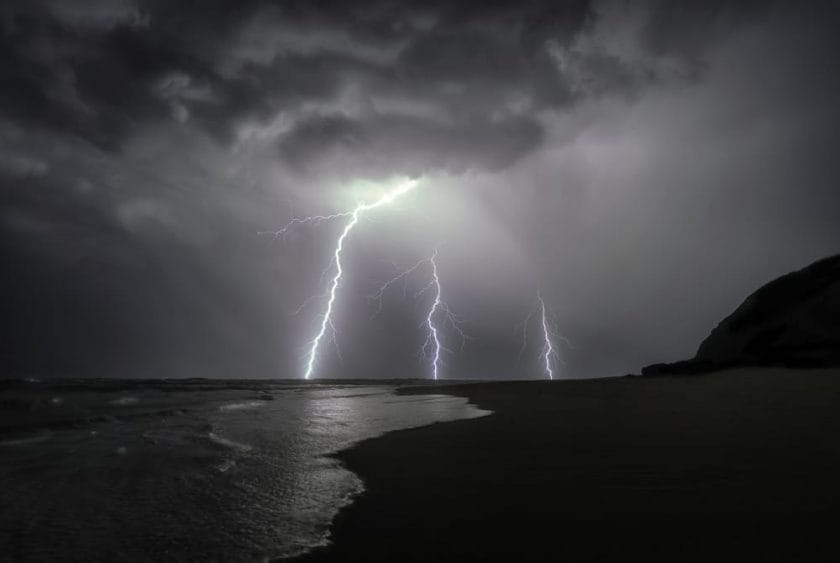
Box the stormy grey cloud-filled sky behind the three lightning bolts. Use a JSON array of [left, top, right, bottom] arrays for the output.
[[0, 0, 840, 378]]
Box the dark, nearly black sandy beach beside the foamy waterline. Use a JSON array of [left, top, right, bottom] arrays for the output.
[[296, 370, 840, 562]]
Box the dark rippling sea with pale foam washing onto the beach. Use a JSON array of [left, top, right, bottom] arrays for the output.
[[0, 380, 487, 561]]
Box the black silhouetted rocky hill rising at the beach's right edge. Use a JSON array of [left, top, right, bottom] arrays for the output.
[[642, 255, 840, 375]]
